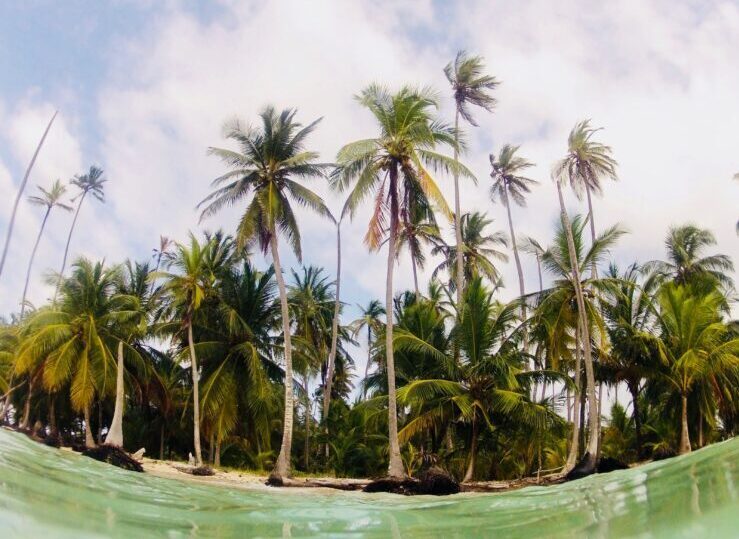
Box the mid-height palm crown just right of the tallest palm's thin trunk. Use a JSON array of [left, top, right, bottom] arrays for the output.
[[431, 212, 508, 289]]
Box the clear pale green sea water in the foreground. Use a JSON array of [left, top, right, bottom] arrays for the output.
[[0, 429, 739, 539]]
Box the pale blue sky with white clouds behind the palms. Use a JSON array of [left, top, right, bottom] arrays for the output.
[[0, 0, 739, 388]]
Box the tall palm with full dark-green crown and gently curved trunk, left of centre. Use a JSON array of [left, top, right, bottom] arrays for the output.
[[198, 107, 331, 483]]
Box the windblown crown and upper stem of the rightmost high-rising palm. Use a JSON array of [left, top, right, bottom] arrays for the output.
[[554, 120, 617, 268]]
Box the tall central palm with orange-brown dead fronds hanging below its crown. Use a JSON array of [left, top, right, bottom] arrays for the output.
[[332, 85, 472, 478]]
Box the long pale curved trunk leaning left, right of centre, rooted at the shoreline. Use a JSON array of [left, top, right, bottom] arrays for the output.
[[556, 181, 600, 474]]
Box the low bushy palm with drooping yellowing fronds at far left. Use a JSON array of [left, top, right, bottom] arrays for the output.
[[16, 258, 136, 447]]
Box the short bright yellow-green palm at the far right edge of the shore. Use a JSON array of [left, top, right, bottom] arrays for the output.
[[657, 283, 739, 454]]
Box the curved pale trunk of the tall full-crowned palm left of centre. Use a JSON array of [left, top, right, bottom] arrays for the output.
[[269, 233, 295, 482]]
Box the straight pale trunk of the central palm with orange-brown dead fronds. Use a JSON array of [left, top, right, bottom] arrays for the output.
[[385, 165, 404, 479]]
